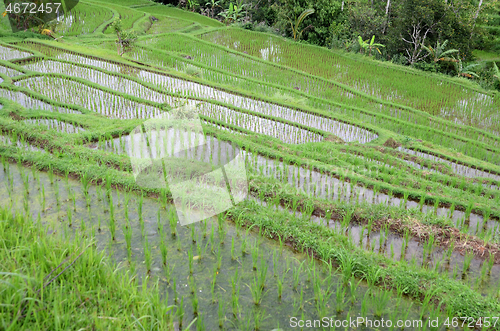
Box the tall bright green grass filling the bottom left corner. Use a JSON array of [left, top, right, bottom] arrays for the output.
[[0, 209, 174, 330]]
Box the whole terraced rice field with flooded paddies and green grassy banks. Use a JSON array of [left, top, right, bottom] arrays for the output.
[[0, 0, 500, 330]]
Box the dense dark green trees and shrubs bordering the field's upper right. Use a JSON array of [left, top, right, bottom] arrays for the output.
[[156, 0, 500, 88]]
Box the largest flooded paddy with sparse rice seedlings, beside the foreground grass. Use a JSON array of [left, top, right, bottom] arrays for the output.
[[0, 163, 456, 330]]
